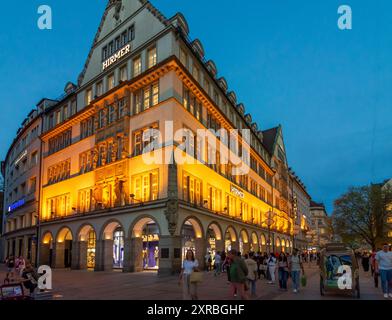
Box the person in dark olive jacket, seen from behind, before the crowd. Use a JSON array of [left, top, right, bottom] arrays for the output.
[[228, 249, 249, 300]]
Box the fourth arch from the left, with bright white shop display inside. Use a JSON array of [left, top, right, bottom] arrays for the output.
[[102, 220, 125, 269]]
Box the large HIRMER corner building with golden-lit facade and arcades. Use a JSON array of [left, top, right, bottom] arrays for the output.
[[1, 0, 304, 274]]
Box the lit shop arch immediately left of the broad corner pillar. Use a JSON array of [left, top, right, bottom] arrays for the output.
[[130, 216, 160, 272]]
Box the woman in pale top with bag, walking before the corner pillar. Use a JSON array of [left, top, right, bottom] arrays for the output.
[[178, 250, 202, 300]]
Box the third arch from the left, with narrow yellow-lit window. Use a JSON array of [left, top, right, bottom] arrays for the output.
[[78, 224, 97, 269]]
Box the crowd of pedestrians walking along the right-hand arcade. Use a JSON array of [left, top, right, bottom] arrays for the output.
[[179, 249, 310, 300]]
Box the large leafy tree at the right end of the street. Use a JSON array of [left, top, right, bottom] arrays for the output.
[[332, 184, 392, 249]]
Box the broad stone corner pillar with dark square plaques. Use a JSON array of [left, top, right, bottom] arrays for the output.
[[158, 236, 181, 276]]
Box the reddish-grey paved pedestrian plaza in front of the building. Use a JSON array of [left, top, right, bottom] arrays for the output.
[[0, 264, 383, 300]]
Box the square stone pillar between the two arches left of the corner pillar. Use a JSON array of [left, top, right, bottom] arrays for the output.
[[123, 238, 143, 272]]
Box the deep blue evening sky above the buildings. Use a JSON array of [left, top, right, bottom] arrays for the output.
[[0, 0, 392, 211]]
